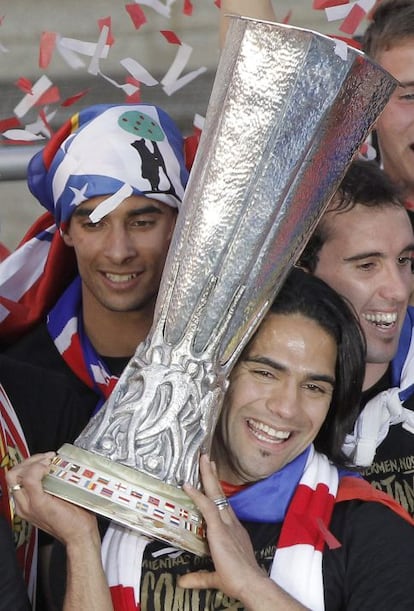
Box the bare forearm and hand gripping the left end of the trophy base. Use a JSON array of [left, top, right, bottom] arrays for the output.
[[7, 452, 113, 611]]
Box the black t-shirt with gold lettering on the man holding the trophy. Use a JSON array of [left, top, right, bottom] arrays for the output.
[[47, 500, 414, 611]]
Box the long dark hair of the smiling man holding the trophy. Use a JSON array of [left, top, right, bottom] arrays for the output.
[[270, 268, 366, 465]]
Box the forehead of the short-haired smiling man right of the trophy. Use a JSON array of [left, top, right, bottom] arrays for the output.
[[324, 204, 414, 253]]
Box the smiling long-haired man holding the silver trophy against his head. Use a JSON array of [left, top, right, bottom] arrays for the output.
[[8, 270, 414, 611]]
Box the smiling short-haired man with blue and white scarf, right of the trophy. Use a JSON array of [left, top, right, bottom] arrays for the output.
[[298, 161, 414, 515]]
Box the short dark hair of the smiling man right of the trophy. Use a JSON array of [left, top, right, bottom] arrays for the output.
[[298, 158, 404, 274]]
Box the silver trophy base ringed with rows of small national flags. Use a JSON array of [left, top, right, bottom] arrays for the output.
[[43, 444, 209, 556]]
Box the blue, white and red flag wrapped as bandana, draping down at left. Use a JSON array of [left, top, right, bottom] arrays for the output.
[[0, 104, 188, 343]]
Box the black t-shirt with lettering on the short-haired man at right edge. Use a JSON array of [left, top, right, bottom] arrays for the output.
[[362, 371, 414, 516]]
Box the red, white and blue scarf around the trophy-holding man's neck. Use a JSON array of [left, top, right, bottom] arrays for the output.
[[102, 446, 340, 611]]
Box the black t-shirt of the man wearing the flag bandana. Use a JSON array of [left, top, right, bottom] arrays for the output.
[[0, 324, 129, 454]]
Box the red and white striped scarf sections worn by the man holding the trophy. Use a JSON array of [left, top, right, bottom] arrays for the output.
[[102, 447, 339, 611]]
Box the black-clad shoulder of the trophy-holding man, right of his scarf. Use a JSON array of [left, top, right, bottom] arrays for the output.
[[323, 499, 414, 611]]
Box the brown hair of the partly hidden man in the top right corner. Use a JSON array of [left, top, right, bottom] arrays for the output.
[[362, 0, 414, 59]]
